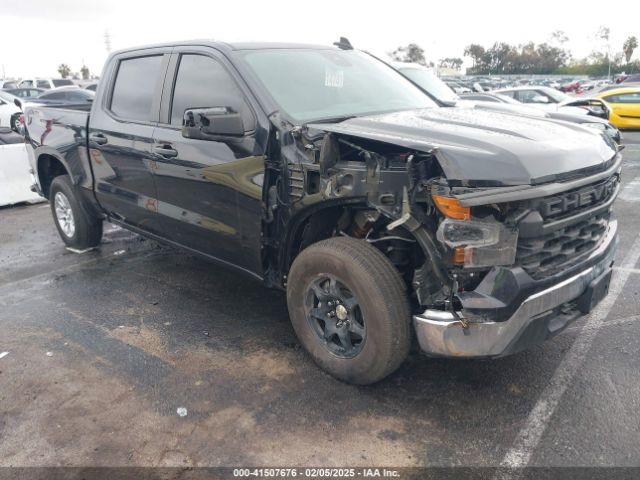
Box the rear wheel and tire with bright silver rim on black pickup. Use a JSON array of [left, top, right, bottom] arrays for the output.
[[49, 175, 102, 250]]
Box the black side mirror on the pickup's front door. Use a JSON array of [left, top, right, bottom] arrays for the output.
[[182, 107, 244, 140]]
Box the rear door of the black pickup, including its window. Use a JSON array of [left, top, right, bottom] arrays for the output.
[[89, 47, 171, 234]]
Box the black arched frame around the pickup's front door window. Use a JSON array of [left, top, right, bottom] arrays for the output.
[[158, 46, 258, 133]]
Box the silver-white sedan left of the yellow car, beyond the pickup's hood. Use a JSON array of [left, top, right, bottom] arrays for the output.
[[493, 85, 610, 120]]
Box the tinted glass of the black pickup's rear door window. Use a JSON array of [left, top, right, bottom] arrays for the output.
[[110, 55, 162, 121]]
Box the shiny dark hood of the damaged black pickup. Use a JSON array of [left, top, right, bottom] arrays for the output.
[[308, 107, 616, 186]]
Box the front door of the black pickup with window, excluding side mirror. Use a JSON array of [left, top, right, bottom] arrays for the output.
[[153, 46, 264, 273]]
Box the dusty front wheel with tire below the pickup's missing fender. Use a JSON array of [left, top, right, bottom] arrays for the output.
[[287, 237, 411, 385]]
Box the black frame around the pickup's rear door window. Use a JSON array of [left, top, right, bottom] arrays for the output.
[[102, 49, 171, 127]]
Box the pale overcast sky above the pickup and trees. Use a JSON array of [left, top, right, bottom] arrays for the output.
[[0, 0, 640, 78]]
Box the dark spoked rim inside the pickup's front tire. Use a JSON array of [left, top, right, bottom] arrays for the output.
[[305, 275, 366, 358]]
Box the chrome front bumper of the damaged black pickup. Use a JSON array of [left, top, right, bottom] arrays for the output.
[[413, 220, 617, 357]]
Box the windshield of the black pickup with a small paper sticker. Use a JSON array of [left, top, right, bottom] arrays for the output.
[[241, 49, 437, 123]]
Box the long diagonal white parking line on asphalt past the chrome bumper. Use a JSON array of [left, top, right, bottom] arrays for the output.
[[500, 236, 640, 468]]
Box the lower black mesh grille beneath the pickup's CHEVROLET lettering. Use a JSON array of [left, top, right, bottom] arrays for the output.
[[516, 212, 610, 280]]
